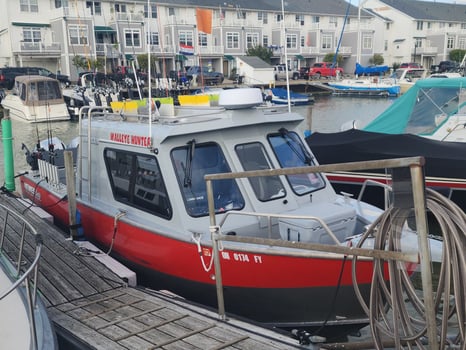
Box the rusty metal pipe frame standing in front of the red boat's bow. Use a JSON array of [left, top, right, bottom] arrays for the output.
[[204, 157, 436, 348]]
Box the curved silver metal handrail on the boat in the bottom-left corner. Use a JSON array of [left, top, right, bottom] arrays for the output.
[[0, 204, 43, 349]]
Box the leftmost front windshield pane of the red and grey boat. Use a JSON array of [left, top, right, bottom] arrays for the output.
[[171, 140, 244, 217]]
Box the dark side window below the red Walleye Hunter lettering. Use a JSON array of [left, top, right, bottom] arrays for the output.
[[104, 149, 172, 219]]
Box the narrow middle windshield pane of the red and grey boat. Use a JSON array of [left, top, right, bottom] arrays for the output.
[[235, 142, 286, 202]]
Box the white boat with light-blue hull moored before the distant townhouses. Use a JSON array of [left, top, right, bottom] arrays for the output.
[[327, 77, 401, 97]]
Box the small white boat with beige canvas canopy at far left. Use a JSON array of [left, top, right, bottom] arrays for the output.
[[1, 75, 70, 123]]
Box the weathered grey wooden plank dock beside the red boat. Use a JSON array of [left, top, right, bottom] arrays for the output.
[[0, 194, 303, 350]]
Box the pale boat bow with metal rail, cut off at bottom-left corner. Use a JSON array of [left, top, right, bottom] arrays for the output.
[[0, 205, 58, 350]]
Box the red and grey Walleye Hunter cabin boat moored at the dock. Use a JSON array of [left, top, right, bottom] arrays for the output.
[[20, 88, 426, 334]]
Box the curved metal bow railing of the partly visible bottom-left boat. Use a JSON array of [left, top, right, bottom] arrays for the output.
[[0, 204, 42, 349]]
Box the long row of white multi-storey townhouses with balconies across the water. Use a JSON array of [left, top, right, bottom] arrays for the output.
[[0, 0, 466, 80]]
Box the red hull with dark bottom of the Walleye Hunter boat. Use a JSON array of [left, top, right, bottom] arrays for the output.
[[21, 177, 384, 326]]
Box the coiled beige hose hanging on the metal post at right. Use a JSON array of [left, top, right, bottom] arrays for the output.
[[352, 189, 466, 350]]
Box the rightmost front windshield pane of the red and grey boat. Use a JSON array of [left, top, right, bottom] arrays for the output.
[[267, 129, 325, 195]]
